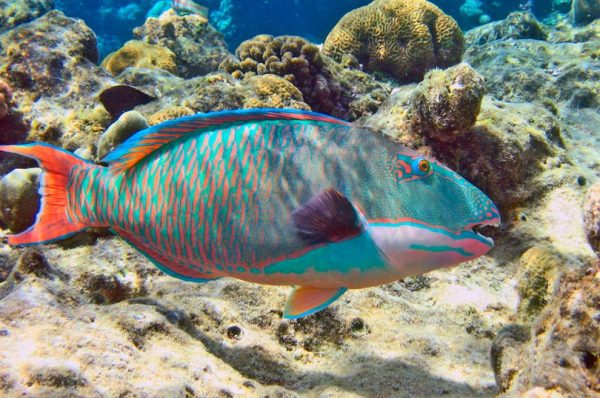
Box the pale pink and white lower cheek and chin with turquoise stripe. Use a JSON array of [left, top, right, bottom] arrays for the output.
[[370, 221, 493, 278]]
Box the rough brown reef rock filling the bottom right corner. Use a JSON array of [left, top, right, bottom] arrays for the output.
[[499, 263, 600, 397]]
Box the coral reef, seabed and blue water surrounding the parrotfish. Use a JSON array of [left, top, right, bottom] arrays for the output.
[[0, 0, 600, 398]]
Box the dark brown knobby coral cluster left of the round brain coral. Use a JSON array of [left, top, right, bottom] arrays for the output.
[[219, 35, 348, 118]]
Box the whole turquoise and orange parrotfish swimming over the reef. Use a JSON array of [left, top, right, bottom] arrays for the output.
[[0, 109, 500, 319]]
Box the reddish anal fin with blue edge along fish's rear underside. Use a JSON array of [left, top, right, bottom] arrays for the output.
[[112, 228, 219, 283]]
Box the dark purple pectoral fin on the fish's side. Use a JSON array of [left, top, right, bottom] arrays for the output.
[[292, 188, 362, 245]]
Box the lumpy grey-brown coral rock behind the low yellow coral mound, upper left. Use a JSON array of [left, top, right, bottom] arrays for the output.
[[133, 10, 229, 78]]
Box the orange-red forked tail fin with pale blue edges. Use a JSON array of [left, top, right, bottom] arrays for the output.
[[0, 144, 87, 245]]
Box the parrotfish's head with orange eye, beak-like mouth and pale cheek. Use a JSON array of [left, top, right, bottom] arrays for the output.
[[370, 149, 500, 275]]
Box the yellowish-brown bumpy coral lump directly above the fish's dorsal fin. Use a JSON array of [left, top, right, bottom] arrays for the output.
[[244, 75, 310, 110]]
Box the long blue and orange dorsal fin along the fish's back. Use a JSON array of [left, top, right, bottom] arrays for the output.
[[103, 108, 350, 173]]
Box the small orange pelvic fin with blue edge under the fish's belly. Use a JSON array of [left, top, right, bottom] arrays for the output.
[[283, 286, 348, 319]]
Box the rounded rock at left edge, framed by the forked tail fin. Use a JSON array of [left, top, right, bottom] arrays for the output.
[[0, 168, 41, 233]]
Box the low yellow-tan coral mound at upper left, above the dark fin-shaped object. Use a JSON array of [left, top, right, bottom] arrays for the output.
[[100, 40, 177, 76]]
